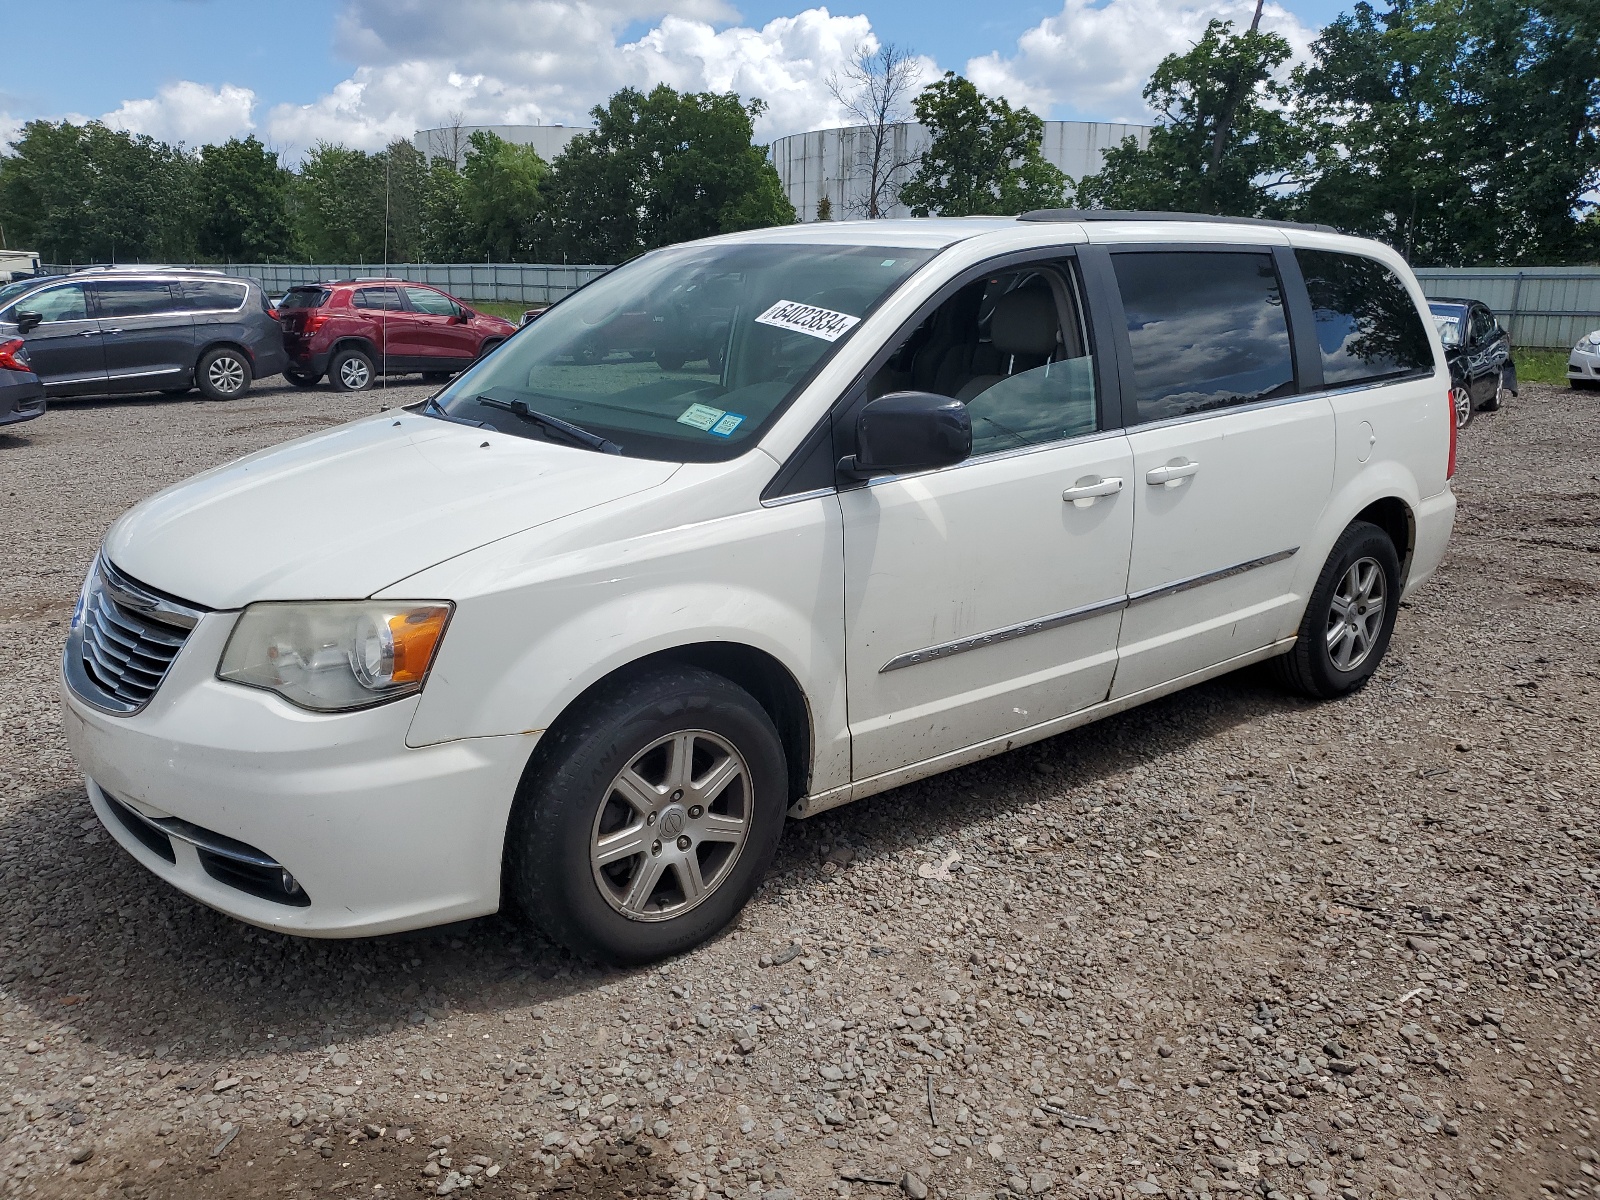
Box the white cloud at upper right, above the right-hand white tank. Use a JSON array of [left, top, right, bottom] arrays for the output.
[[966, 0, 1315, 122]]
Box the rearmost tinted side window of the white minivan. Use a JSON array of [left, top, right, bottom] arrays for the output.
[[1294, 250, 1443, 387]]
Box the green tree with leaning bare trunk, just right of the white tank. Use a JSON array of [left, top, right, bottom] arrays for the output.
[[1077, 19, 1306, 216]]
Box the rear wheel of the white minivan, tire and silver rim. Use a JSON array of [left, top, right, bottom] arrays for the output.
[[1274, 522, 1400, 699]]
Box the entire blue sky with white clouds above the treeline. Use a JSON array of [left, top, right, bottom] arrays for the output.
[[0, 0, 1346, 155]]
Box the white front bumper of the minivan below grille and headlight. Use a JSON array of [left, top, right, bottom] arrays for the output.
[[62, 613, 534, 938]]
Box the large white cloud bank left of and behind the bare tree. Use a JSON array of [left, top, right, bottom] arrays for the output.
[[266, 0, 908, 154]]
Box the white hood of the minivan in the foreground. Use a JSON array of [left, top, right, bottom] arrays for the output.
[[106, 411, 678, 608]]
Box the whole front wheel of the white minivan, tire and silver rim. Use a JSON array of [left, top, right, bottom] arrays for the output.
[[506, 666, 789, 965]]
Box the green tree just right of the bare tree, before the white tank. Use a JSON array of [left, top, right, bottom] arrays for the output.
[[901, 70, 1072, 216]]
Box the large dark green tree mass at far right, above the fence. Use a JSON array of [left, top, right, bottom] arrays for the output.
[[1293, 0, 1600, 266]]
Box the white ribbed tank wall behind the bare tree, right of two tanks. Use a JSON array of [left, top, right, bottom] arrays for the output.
[[771, 122, 1150, 221]]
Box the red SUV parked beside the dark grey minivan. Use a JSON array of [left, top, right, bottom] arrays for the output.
[[278, 280, 517, 392]]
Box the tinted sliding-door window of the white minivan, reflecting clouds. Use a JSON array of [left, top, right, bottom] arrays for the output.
[[1112, 251, 1294, 424]]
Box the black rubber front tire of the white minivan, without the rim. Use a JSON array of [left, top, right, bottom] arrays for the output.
[[506, 667, 789, 963]]
